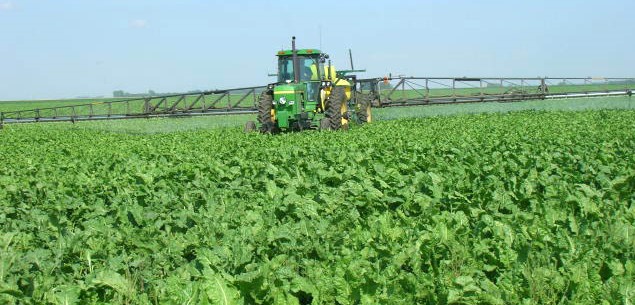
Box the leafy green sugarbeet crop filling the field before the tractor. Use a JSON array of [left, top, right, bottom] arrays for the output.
[[0, 106, 635, 304]]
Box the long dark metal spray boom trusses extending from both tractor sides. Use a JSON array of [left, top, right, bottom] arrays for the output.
[[0, 76, 635, 127]]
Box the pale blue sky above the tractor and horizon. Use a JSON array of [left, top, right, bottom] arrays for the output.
[[0, 0, 635, 100]]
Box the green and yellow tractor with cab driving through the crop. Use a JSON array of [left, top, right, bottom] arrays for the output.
[[245, 37, 372, 133]]
